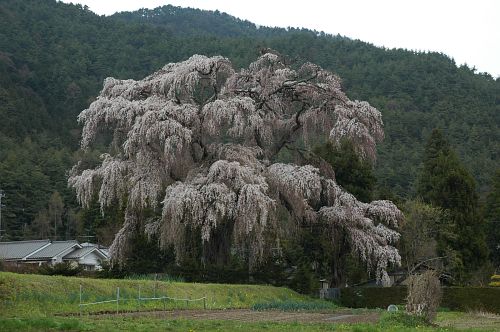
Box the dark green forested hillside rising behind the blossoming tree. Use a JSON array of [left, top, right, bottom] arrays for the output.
[[0, 0, 500, 239]]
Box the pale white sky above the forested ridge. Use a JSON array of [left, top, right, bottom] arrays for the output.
[[63, 0, 500, 77]]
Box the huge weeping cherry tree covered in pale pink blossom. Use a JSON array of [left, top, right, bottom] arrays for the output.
[[69, 53, 402, 281]]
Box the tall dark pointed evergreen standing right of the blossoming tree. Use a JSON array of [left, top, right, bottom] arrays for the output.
[[417, 129, 487, 281]]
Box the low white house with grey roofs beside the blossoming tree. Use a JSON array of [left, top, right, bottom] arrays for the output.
[[0, 240, 109, 271]]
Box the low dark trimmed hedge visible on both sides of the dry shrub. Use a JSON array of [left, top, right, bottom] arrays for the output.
[[340, 287, 500, 313]]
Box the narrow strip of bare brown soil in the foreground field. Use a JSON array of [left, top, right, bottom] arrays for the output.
[[89, 309, 380, 323]]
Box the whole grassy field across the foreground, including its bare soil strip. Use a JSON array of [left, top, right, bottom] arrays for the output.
[[0, 272, 500, 332]]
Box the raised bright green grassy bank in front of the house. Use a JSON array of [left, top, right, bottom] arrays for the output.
[[0, 272, 309, 317]]
